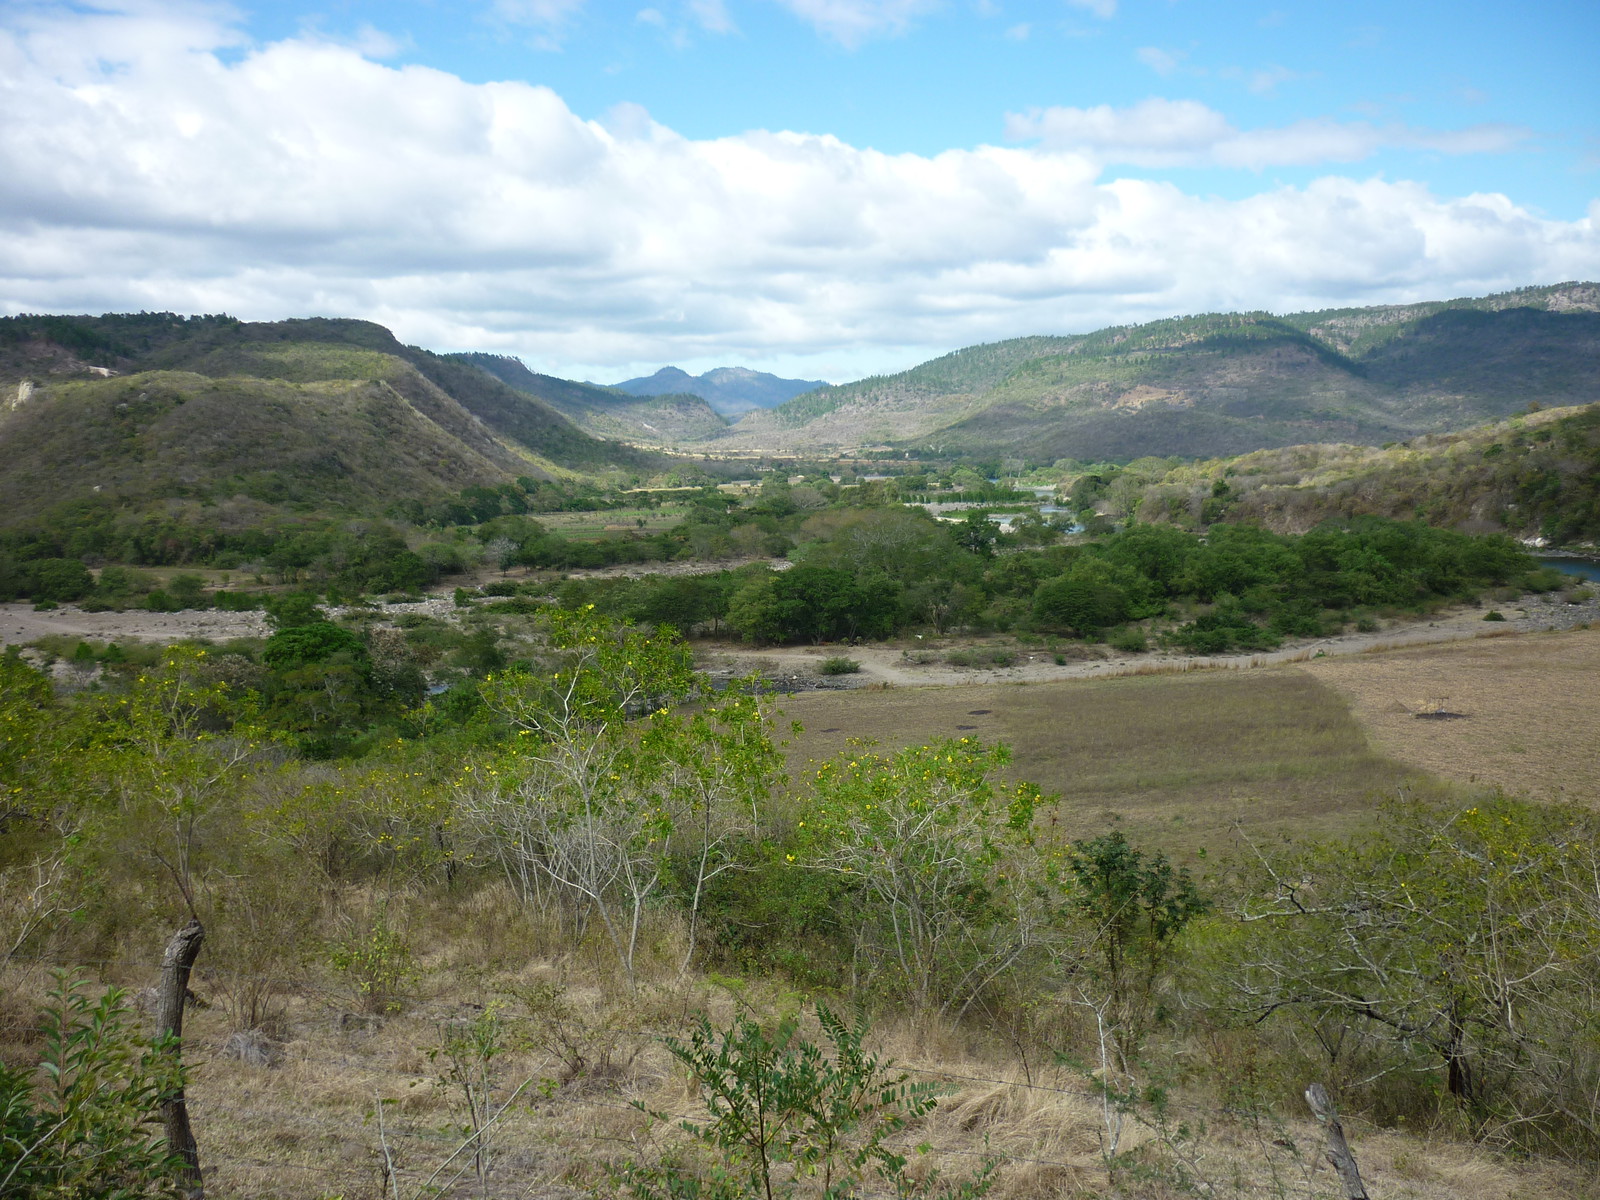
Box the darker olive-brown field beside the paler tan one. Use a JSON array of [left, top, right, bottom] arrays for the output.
[[784, 658, 1430, 854]]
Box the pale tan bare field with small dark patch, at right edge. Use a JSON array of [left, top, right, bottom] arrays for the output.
[[1302, 629, 1600, 805]]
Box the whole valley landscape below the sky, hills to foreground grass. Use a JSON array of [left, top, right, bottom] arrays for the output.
[[0, 285, 1600, 1200]]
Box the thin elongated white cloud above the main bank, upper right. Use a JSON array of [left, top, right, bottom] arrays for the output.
[[1006, 98, 1530, 170]]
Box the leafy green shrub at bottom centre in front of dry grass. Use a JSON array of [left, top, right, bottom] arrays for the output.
[[622, 1008, 997, 1200]]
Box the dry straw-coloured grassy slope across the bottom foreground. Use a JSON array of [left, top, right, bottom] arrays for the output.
[[8, 908, 1600, 1200]]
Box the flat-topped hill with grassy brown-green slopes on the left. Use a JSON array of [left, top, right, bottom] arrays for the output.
[[0, 314, 653, 525]]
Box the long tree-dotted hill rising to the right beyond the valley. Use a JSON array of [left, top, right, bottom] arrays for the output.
[[718, 283, 1600, 461]]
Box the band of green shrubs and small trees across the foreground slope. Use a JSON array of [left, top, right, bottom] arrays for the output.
[[0, 608, 1600, 1197]]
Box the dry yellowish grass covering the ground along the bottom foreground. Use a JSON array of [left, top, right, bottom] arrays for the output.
[[21, 963, 1600, 1200]]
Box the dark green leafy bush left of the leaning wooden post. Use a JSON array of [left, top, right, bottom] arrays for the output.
[[0, 973, 182, 1200]]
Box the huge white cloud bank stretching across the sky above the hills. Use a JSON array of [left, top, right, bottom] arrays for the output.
[[0, 6, 1600, 378]]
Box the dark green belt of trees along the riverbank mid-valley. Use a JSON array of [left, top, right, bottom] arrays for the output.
[[558, 509, 1560, 653]]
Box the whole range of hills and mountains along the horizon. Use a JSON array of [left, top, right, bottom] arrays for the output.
[[0, 283, 1600, 525]]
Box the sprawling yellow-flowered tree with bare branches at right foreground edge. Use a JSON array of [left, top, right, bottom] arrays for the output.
[[1218, 797, 1600, 1152]]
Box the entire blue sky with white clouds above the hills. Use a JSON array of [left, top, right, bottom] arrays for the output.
[[0, 0, 1600, 381]]
